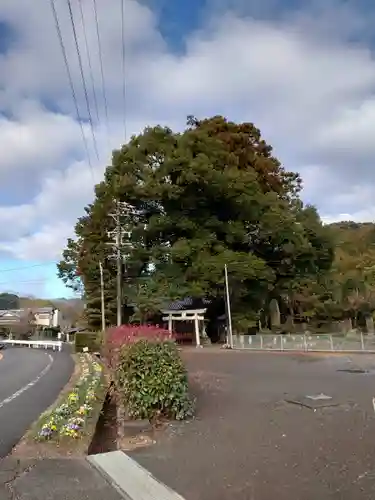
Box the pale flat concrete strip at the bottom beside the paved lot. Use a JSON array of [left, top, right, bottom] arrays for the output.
[[87, 450, 185, 500]]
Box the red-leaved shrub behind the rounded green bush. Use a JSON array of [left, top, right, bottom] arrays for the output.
[[103, 325, 173, 369]]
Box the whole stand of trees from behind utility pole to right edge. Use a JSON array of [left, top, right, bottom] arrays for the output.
[[58, 116, 375, 336]]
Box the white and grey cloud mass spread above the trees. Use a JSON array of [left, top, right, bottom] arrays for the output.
[[0, 0, 375, 286]]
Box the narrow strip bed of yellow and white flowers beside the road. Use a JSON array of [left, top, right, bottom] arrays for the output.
[[35, 354, 103, 441]]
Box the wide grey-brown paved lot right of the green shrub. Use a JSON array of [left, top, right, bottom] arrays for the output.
[[132, 349, 375, 500]]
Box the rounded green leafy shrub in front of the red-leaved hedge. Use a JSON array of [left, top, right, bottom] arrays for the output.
[[116, 340, 194, 420]]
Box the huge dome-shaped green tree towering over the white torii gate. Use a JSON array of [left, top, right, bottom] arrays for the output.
[[59, 116, 333, 328]]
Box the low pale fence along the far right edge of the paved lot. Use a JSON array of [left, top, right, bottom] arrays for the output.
[[233, 333, 375, 353]]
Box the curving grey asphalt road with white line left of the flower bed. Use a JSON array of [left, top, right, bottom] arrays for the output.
[[0, 348, 74, 458]]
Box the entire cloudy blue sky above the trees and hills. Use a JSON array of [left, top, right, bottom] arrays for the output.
[[0, 0, 375, 298]]
